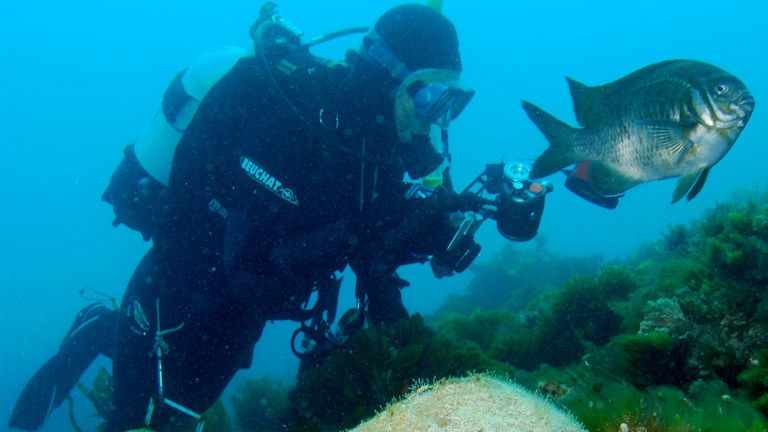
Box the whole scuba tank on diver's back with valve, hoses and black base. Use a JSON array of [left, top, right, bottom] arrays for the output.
[[106, 2, 366, 240]]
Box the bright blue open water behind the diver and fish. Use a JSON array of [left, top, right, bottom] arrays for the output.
[[0, 0, 768, 431]]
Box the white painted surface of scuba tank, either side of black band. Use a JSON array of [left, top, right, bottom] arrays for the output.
[[134, 46, 253, 185]]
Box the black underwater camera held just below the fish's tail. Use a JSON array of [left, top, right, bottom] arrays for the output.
[[465, 160, 553, 241]]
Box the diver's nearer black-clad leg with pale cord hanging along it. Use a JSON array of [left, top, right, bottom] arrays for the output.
[[106, 251, 265, 432]]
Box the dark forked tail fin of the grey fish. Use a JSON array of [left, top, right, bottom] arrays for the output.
[[523, 101, 578, 178]]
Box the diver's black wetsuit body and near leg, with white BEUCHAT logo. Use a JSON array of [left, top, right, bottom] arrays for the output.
[[108, 50, 412, 431]]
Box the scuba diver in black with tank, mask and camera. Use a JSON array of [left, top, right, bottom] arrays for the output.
[[9, 3, 552, 431]]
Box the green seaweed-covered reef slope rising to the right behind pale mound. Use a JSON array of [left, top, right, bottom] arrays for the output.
[[79, 188, 768, 432]]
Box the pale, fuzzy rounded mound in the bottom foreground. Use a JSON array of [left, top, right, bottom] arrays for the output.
[[350, 375, 584, 432]]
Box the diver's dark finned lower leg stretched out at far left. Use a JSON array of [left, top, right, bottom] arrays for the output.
[[8, 303, 117, 430]]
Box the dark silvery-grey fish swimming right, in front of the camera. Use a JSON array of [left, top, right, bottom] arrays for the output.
[[523, 59, 755, 203]]
